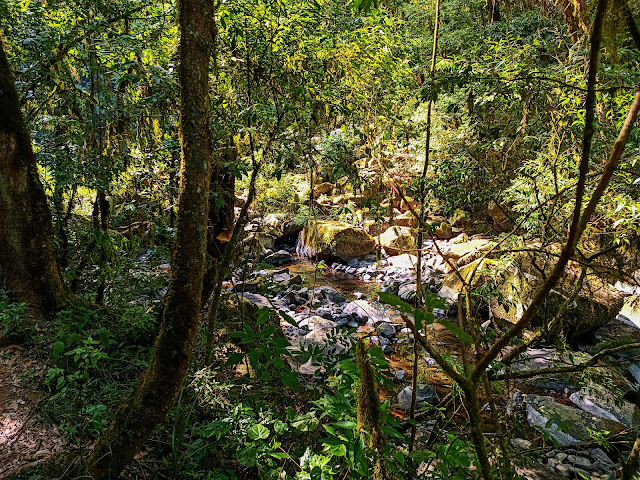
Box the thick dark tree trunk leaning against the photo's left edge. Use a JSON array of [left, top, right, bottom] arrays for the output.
[[0, 32, 69, 315]]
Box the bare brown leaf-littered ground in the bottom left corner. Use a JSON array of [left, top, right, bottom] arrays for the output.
[[0, 345, 66, 479]]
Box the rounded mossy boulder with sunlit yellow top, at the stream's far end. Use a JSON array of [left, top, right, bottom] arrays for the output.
[[297, 220, 375, 262]]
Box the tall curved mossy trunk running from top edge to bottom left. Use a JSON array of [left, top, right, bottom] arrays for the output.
[[87, 0, 214, 474]]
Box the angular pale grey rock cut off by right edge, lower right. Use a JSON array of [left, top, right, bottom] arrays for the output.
[[569, 385, 640, 427]]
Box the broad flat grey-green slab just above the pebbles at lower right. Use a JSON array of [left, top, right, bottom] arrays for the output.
[[525, 394, 624, 445]]
